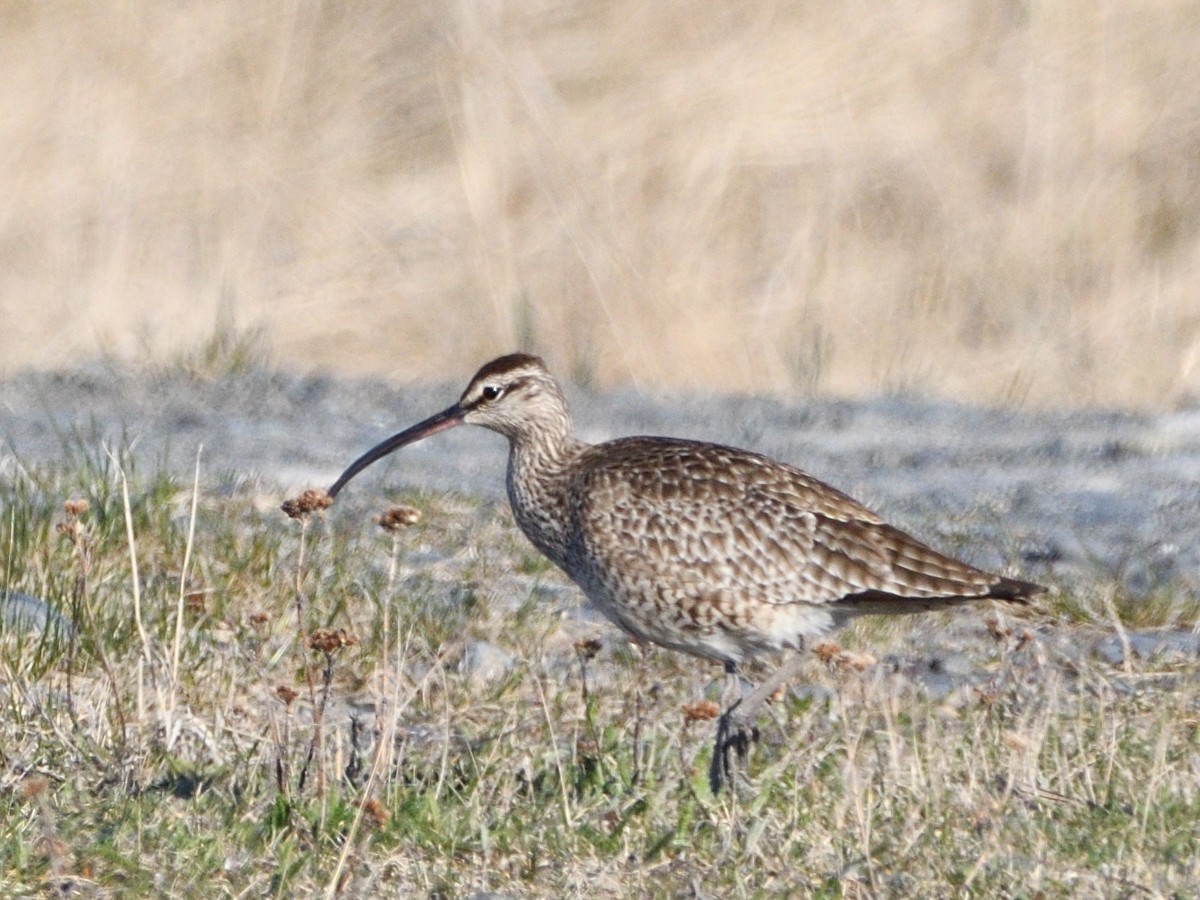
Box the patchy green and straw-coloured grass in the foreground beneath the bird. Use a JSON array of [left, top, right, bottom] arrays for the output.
[[0, 444, 1200, 898]]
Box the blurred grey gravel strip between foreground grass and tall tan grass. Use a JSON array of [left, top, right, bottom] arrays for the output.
[[0, 365, 1200, 596]]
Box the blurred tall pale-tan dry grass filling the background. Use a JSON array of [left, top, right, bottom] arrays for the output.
[[0, 0, 1200, 407]]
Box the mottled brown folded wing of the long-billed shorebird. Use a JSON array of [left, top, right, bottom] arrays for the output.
[[572, 438, 1032, 606]]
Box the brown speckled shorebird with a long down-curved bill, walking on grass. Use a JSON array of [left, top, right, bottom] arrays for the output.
[[328, 353, 1044, 793]]
